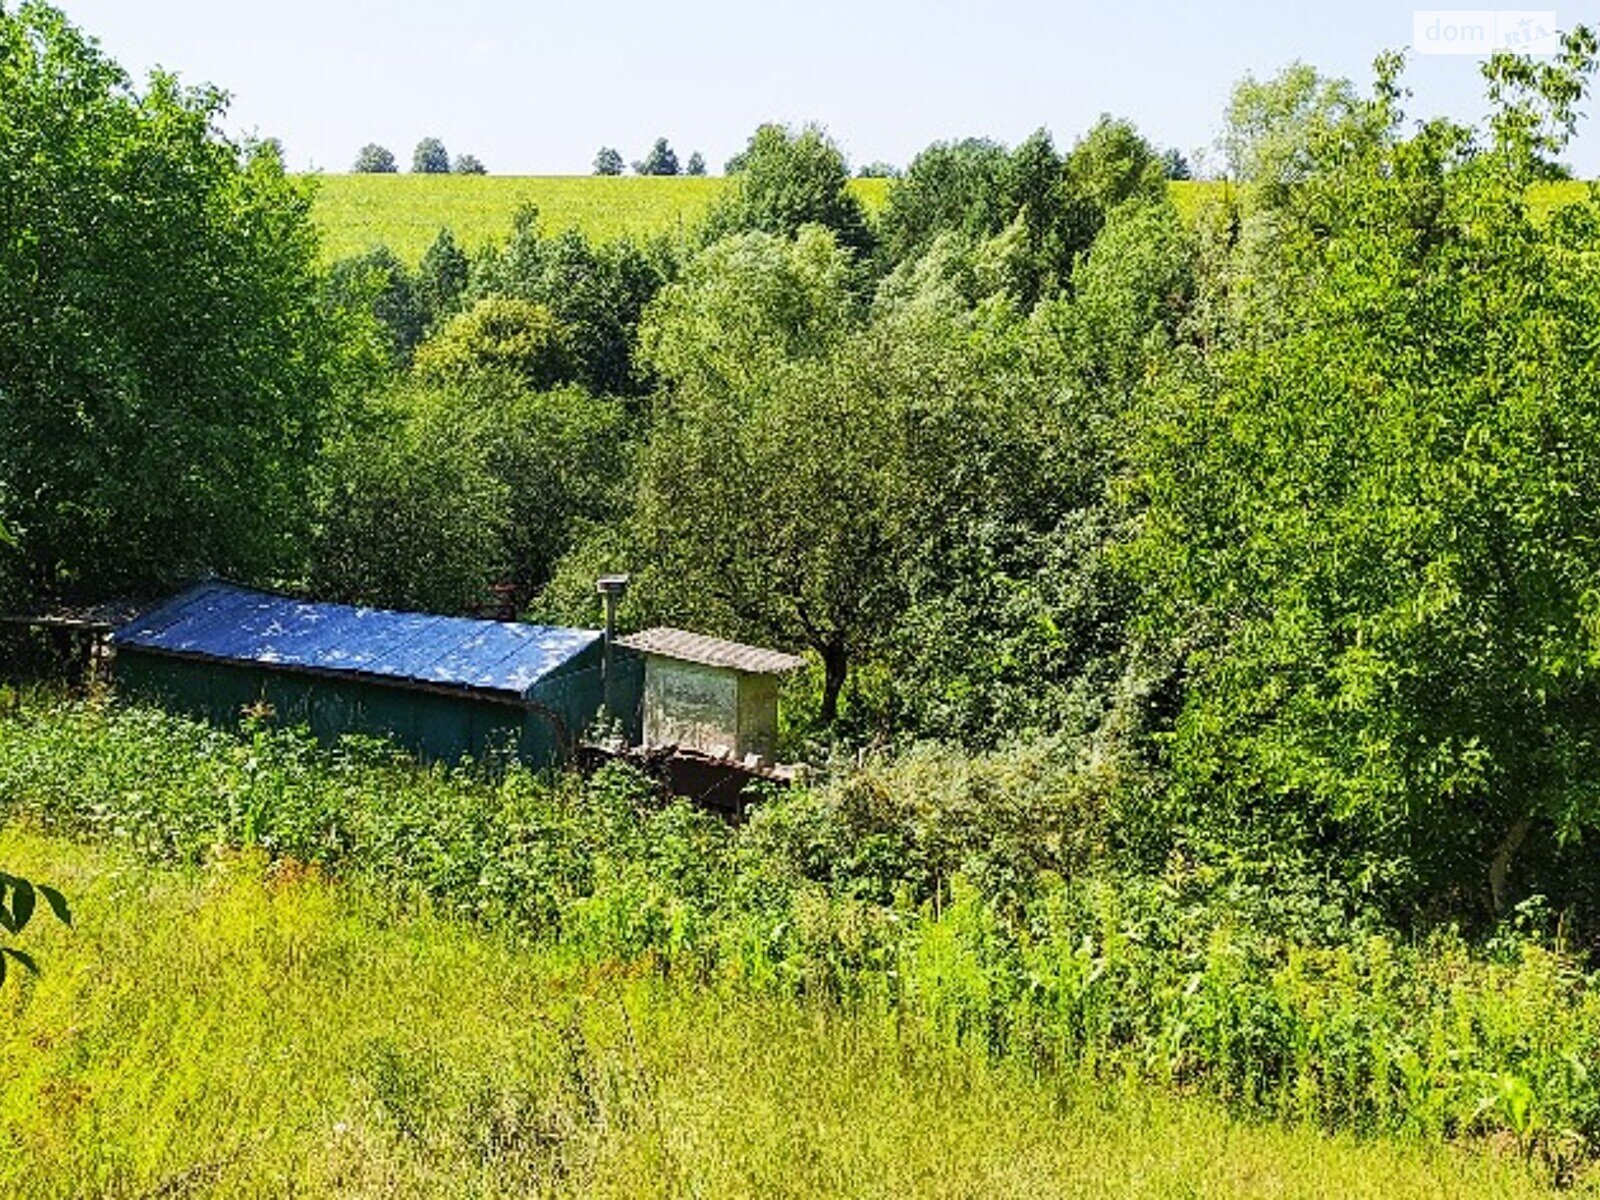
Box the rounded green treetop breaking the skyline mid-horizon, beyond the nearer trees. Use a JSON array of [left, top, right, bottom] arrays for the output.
[[704, 125, 874, 253]]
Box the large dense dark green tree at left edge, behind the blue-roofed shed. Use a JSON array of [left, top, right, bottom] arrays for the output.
[[0, 3, 339, 597]]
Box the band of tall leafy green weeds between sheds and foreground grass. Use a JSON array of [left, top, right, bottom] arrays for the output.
[[0, 702, 1600, 1178]]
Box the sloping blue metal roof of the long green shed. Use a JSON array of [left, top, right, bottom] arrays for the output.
[[112, 582, 600, 696]]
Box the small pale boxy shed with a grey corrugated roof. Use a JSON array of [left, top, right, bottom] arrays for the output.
[[618, 627, 805, 762]]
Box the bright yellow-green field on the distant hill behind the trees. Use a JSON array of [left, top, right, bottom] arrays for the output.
[[302, 174, 1586, 262]]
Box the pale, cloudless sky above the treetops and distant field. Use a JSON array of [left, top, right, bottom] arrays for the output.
[[58, 0, 1600, 178]]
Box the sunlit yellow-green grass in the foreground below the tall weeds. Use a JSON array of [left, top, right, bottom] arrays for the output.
[[0, 830, 1574, 1198]]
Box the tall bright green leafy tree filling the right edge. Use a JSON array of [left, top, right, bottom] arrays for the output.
[[1133, 29, 1600, 912]]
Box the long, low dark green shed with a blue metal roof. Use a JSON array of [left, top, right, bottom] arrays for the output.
[[112, 582, 602, 765]]
